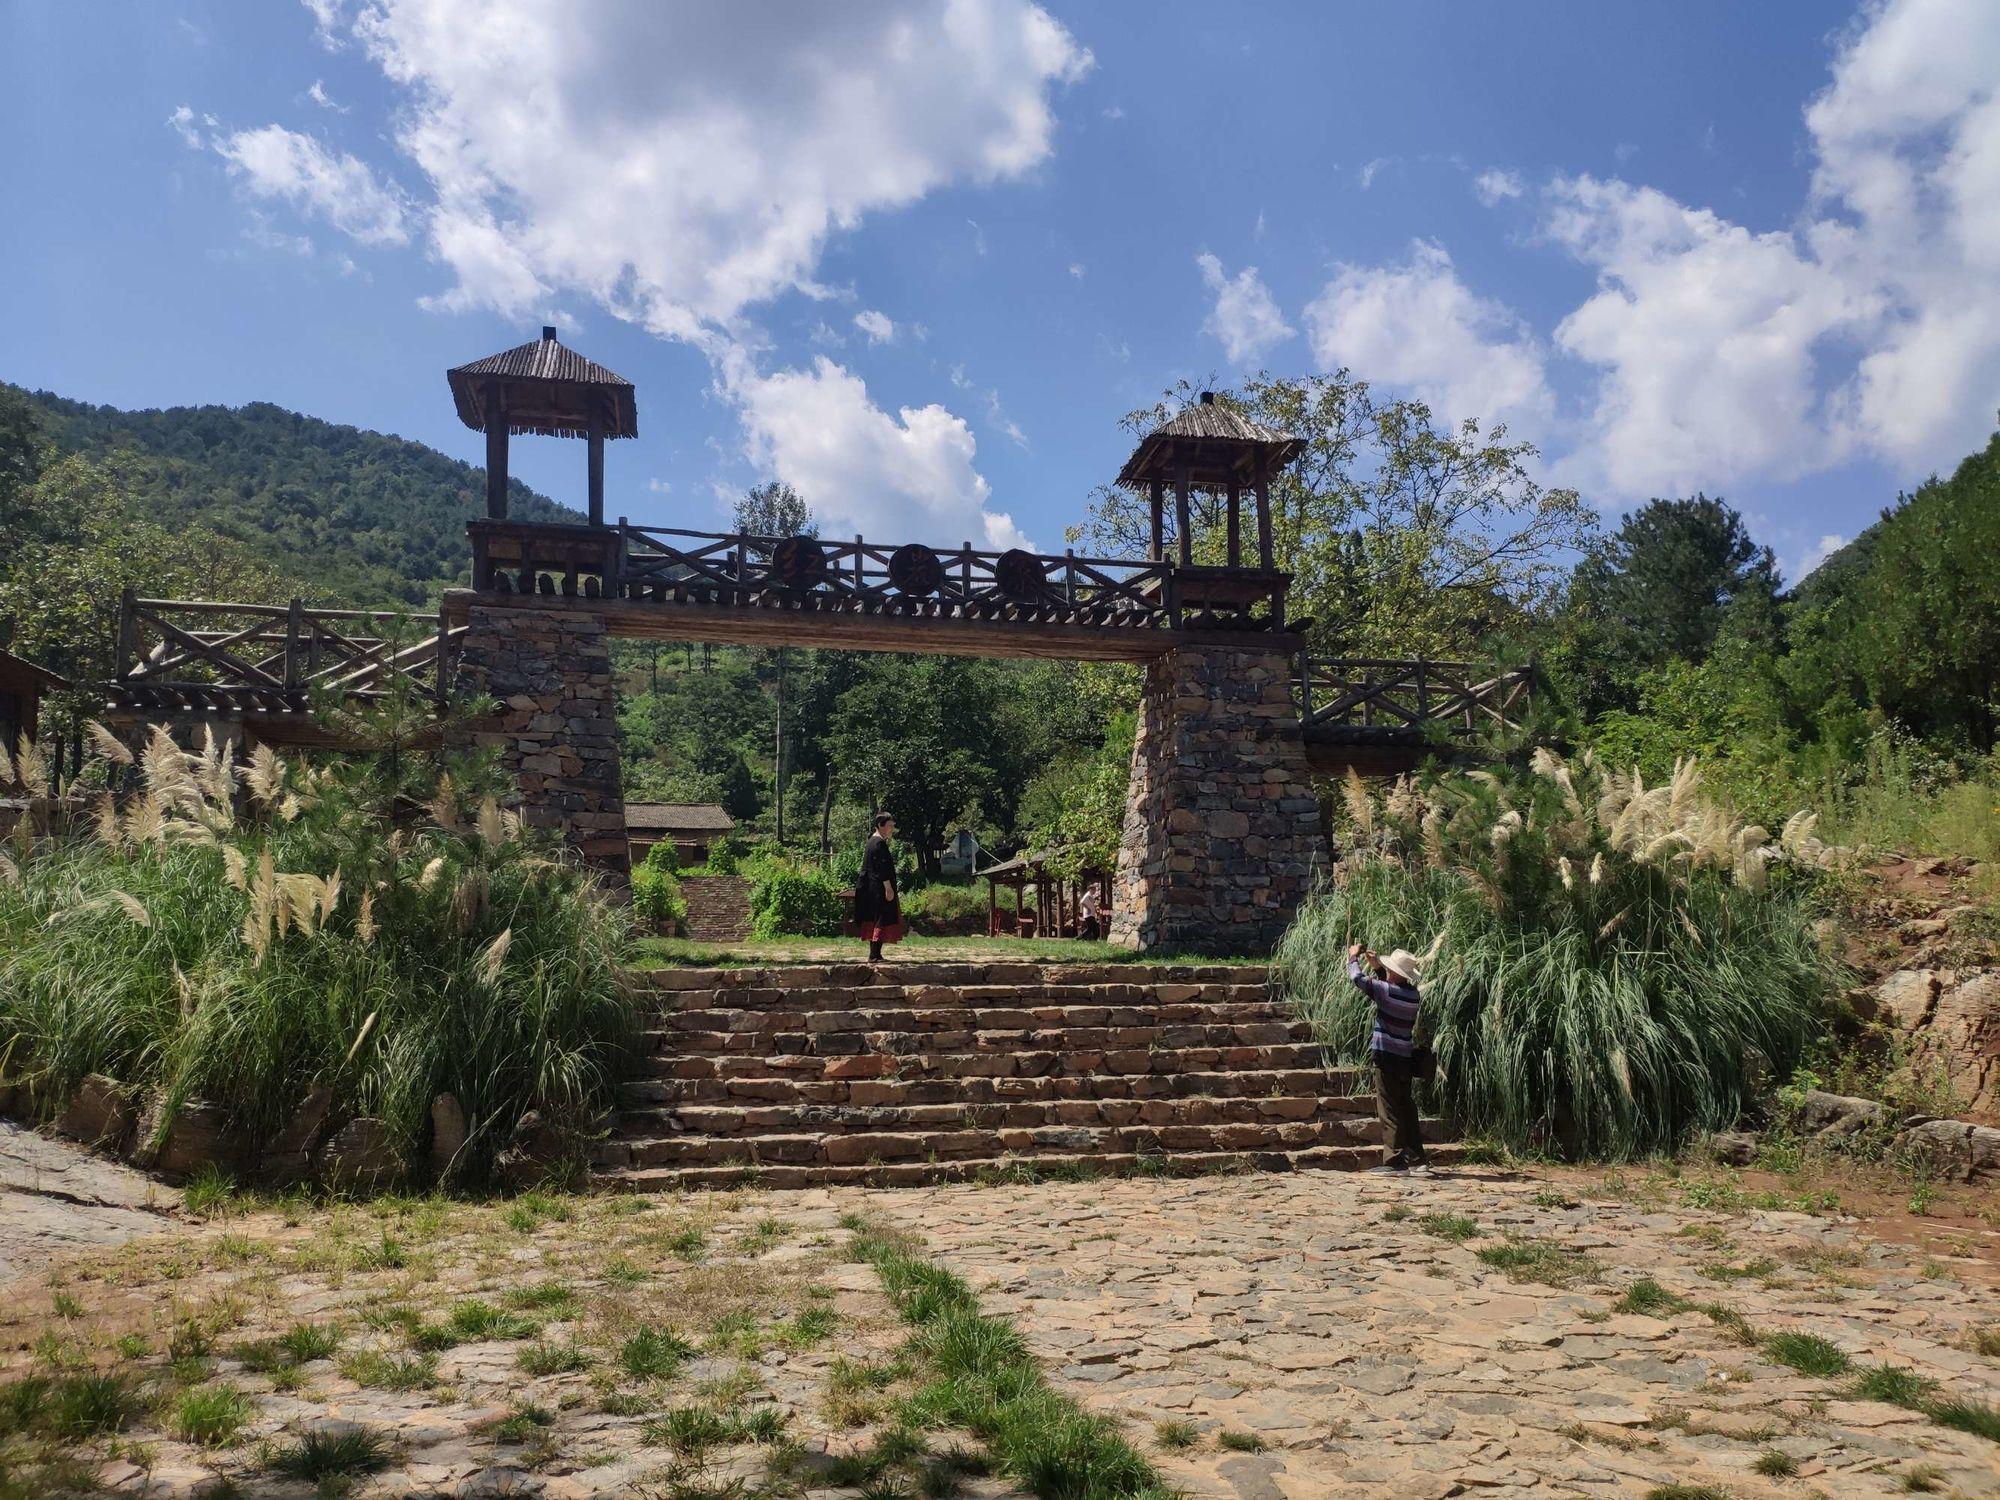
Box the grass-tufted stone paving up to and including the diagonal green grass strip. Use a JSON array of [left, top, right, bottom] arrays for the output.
[[0, 1192, 1158, 1500]]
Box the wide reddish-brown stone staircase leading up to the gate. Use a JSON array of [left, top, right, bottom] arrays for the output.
[[598, 962, 1434, 1190]]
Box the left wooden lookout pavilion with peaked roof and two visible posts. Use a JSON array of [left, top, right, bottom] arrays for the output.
[[444, 328, 638, 526]]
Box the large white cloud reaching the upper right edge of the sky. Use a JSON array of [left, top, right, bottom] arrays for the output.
[[1548, 0, 2000, 496]]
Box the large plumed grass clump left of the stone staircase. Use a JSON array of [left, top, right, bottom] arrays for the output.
[[0, 726, 634, 1180]]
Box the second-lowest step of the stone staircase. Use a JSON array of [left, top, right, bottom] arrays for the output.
[[596, 1112, 1424, 1170]]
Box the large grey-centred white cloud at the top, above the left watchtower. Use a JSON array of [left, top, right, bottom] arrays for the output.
[[320, 0, 1090, 340]]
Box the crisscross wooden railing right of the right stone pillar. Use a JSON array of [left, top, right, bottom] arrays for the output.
[[1298, 656, 1534, 732]]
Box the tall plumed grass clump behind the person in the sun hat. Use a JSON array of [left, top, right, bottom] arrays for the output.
[[1276, 750, 1844, 1158]]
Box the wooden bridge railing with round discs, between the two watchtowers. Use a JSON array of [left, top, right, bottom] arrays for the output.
[[470, 518, 1286, 630]]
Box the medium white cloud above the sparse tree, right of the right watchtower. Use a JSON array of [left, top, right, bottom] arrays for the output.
[[1306, 240, 1552, 434]]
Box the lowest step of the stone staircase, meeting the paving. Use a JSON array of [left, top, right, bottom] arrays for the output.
[[598, 1132, 1462, 1192]]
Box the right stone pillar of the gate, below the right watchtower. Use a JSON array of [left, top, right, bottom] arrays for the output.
[[1110, 646, 1330, 952]]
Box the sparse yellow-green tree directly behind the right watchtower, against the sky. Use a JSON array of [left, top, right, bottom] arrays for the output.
[[1072, 370, 1592, 656]]
